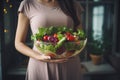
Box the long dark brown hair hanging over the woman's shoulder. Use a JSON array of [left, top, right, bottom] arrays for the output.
[[57, 0, 80, 27]]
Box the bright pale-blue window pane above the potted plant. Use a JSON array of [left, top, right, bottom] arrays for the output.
[[92, 6, 104, 40]]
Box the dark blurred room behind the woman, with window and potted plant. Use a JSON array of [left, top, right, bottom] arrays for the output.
[[0, 0, 120, 80]]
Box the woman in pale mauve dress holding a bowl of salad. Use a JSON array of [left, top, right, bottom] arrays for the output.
[[15, 0, 82, 80]]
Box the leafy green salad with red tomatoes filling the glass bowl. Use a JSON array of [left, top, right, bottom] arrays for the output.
[[31, 26, 86, 58]]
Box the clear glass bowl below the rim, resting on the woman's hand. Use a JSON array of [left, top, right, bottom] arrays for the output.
[[35, 38, 87, 62]]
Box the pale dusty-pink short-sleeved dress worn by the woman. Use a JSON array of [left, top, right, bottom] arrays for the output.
[[18, 0, 82, 80]]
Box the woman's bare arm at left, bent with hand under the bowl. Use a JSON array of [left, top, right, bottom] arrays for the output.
[[15, 13, 50, 60]]
